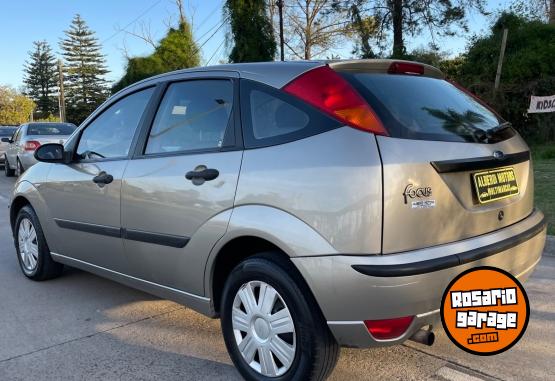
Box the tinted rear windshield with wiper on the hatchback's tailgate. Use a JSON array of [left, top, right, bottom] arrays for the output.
[[342, 73, 514, 143]]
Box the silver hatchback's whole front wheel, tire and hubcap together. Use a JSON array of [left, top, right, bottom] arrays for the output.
[[14, 205, 63, 281]]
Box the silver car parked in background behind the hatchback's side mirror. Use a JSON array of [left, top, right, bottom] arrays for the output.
[[2, 122, 77, 177]]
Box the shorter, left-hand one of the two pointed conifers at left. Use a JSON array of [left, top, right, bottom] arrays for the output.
[[23, 41, 58, 119]]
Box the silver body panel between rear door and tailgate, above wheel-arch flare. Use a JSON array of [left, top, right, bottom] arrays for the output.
[[235, 127, 382, 256]]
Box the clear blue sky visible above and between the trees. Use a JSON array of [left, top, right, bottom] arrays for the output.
[[0, 0, 507, 88]]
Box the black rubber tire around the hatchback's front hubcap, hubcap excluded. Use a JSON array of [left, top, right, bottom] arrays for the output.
[[14, 205, 64, 281]]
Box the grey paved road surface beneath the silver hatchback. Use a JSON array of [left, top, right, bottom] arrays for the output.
[[0, 176, 555, 381]]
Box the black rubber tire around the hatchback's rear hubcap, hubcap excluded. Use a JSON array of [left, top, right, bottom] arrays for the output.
[[220, 253, 339, 381]]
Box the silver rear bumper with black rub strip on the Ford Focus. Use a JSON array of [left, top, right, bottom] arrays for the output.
[[292, 211, 546, 347]]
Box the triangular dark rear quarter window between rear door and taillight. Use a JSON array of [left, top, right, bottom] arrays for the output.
[[241, 80, 341, 148]]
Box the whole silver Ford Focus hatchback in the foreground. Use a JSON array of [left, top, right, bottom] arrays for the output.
[[10, 60, 546, 380]]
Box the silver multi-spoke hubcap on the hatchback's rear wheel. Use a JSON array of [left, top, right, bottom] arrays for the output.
[[231, 281, 297, 377]]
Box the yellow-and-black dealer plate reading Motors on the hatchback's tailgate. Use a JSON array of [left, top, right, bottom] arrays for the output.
[[472, 167, 519, 204]]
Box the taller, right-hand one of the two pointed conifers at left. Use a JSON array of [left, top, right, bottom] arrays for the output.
[[60, 14, 109, 124]]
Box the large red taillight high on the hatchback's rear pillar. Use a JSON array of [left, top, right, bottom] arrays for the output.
[[283, 66, 387, 135]]
